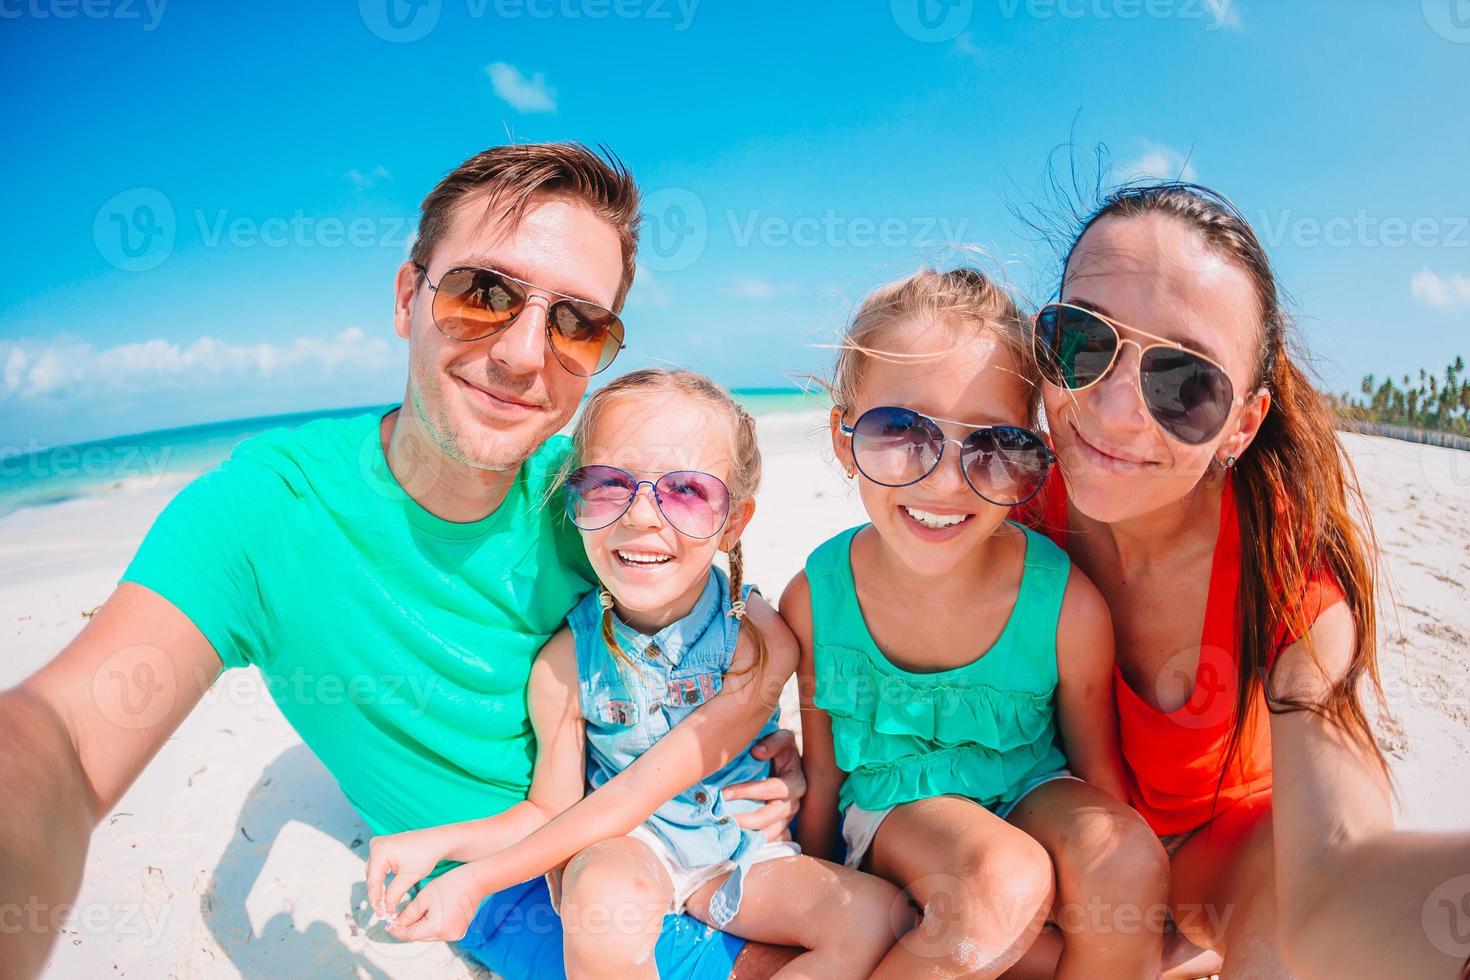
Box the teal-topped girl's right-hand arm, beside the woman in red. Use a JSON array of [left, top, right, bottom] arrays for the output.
[[1057, 566, 1127, 802]]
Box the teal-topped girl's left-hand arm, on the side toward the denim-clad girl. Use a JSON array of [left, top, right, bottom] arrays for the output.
[[781, 572, 847, 860]]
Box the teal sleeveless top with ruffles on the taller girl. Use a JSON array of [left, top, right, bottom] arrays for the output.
[[806, 525, 1072, 830]]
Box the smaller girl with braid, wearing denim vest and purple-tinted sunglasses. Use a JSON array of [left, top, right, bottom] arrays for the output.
[[369, 370, 907, 977]]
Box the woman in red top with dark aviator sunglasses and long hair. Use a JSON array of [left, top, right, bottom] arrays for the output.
[[1026, 184, 1470, 977]]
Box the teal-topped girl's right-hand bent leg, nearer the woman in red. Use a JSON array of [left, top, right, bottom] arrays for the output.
[[1010, 779, 1169, 980]]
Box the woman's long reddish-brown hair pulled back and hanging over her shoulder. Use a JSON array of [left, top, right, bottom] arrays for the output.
[[1063, 182, 1388, 780]]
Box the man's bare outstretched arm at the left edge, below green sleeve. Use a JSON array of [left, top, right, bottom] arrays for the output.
[[0, 583, 221, 977]]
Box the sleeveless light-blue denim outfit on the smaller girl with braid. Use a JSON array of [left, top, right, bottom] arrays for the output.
[[567, 566, 776, 926]]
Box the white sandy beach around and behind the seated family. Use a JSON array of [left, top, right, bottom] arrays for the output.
[[0, 416, 1470, 977]]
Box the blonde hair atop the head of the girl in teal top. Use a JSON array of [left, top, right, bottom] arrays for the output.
[[819, 266, 1041, 425]]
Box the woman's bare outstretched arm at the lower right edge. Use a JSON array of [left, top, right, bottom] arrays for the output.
[[1270, 602, 1470, 977]]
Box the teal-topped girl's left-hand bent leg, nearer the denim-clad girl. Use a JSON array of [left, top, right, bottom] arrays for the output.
[[867, 796, 1054, 980]]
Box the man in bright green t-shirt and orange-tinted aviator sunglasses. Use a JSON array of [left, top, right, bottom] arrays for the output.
[[0, 144, 804, 977]]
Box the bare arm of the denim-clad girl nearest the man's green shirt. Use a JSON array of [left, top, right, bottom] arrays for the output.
[[368, 627, 587, 917]]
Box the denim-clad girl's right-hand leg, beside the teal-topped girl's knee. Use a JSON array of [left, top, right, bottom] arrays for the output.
[[688, 857, 914, 979]]
